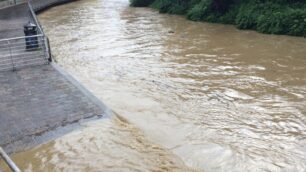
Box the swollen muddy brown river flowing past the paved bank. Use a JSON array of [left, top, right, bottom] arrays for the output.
[[2, 0, 306, 172]]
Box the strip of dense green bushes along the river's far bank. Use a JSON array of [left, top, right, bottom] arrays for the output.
[[131, 0, 306, 37]]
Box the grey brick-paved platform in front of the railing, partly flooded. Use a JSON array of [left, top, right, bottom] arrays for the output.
[[0, 65, 103, 151]]
